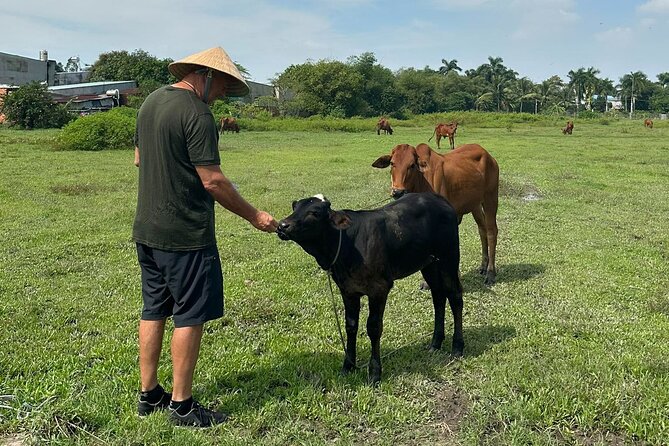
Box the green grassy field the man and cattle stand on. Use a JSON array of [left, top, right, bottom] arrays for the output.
[[0, 121, 669, 445]]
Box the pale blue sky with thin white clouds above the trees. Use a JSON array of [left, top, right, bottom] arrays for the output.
[[0, 0, 669, 83]]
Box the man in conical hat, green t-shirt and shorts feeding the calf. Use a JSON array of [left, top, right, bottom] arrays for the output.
[[132, 47, 277, 427]]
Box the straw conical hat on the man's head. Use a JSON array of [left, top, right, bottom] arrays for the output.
[[168, 46, 250, 97]]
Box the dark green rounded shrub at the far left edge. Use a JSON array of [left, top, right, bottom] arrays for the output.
[[0, 82, 72, 129]]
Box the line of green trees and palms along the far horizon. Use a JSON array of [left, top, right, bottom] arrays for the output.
[[74, 50, 669, 118]]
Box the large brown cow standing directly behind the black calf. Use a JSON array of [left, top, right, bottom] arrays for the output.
[[372, 144, 499, 285]]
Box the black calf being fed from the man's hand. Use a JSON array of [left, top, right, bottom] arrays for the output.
[[277, 193, 464, 384]]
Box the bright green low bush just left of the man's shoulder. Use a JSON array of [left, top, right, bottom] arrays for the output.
[[58, 107, 137, 151]]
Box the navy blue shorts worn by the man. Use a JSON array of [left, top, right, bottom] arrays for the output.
[[137, 243, 223, 327]]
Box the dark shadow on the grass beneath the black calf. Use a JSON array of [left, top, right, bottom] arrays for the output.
[[207, 325, 516, 413]]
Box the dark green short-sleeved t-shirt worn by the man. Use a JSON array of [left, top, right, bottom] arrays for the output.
[[132, 86, 221, 251]]
